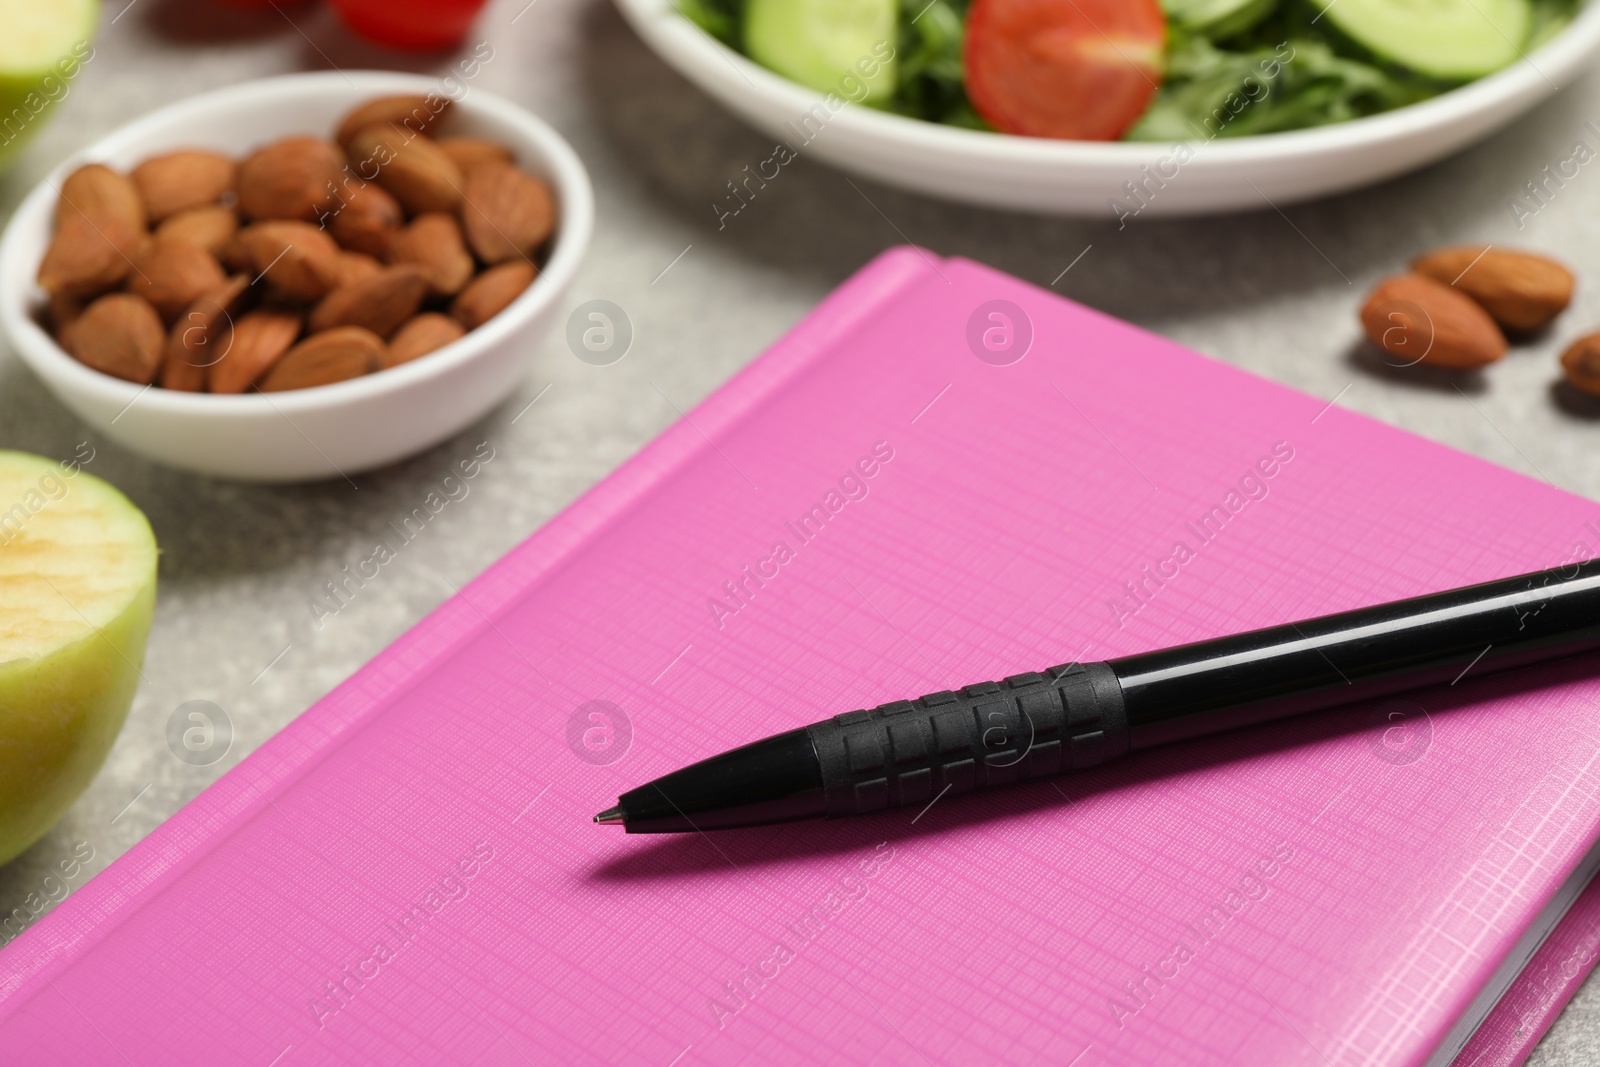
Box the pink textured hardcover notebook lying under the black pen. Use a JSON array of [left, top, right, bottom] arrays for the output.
[[0, 250, 1600, 1067]]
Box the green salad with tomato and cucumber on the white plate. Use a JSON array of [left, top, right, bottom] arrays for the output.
[[677, 0, 1582, 141]]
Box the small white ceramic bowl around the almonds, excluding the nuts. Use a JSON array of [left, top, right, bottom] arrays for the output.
[[0, 70, 594, 482]]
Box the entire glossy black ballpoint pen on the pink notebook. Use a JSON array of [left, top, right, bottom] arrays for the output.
[[595, 560, 1600, 833]]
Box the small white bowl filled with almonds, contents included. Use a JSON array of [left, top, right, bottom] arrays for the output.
[[0, 72, 594, 482]]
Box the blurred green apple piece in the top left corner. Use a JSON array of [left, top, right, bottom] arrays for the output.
[[0, 0, 99, 168]]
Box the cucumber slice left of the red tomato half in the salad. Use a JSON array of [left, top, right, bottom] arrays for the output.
[[744, 0, 899, 106]]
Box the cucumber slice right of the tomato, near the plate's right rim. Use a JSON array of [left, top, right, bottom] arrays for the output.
[[1323, 0, 1533, 80]]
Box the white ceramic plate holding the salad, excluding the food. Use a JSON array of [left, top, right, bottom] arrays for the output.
[[616, 0, 1600, 218]]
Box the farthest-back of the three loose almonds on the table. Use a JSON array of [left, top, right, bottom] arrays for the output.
[[1411, 245, 1573, 333]]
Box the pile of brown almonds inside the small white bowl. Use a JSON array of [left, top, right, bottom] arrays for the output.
[[38, 96, 557, 394]]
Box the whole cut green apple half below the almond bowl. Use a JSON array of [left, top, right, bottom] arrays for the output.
[[0, 451, 157, 864]]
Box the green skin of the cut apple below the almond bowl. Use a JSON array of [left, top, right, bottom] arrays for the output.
[[0, 451, 158, 864]]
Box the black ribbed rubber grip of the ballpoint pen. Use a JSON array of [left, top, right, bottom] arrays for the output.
[[806, 662, 1128, 817]]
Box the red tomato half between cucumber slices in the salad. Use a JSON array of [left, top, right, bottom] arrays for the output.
[[963, 0, 1166, 141]]
